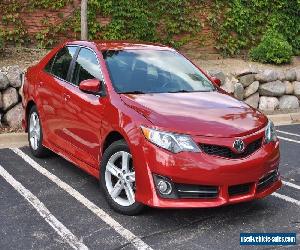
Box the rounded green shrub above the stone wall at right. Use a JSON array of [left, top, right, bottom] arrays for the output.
[[250, 31, 293, 64]]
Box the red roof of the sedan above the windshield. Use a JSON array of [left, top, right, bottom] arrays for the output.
[[67, 41, 174, 51]]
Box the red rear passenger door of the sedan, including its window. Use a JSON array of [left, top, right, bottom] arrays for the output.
[[37, 46, 78, 148]]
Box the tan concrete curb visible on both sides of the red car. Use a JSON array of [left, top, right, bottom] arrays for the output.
[[0, 112, 300, 148]]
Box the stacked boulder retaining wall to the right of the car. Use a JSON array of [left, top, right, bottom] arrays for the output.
[[210, 68, 300, 111]]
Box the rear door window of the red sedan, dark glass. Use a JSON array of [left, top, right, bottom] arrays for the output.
[[52, 46, 77, 80]]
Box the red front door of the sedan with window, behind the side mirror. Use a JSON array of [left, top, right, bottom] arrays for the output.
[[62, 47, 107, 168]]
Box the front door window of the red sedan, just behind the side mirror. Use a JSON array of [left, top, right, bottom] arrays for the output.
[[71, 48, 102, 86]]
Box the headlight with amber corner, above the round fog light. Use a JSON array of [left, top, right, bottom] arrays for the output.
[[141, 127, 200, 153]]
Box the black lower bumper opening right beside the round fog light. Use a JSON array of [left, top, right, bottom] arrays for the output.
[[174, 184, 219, 199]]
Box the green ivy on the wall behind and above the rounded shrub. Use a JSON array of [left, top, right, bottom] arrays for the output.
[[209, 0, 300, 60]]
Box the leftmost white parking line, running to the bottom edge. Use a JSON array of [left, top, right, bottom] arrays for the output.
[[0, 165, 88, 250]]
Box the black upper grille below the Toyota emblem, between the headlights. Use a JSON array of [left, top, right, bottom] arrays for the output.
[[199, 138, 262, 159]]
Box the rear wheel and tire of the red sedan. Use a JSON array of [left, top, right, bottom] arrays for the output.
[[27, 106, 49, 158]]
